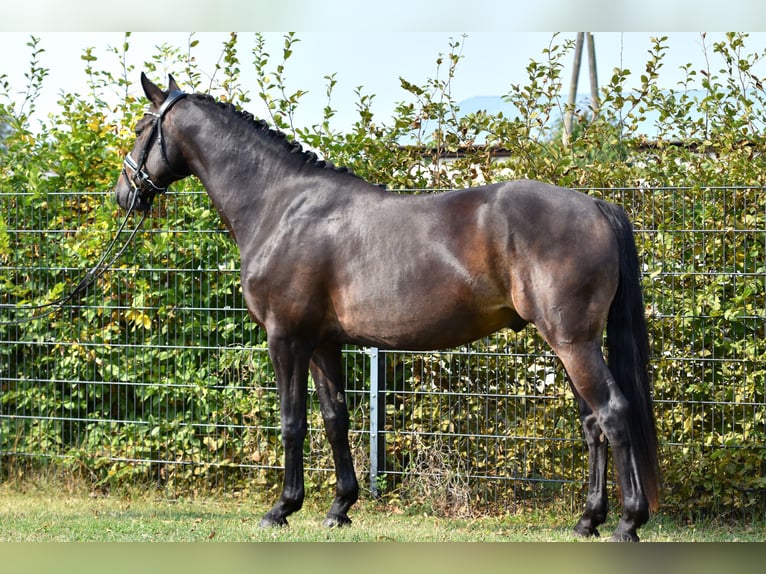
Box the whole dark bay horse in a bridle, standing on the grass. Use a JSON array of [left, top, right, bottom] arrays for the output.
[[114, 73, 659, 541]]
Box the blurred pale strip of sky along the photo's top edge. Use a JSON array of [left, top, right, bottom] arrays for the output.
[[0, 0, 763, 34]]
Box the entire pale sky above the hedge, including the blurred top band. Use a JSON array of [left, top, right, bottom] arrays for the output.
[[0, 0, 766, 129]]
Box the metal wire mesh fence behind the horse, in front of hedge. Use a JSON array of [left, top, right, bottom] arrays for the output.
[[0, 186, 766, 514]]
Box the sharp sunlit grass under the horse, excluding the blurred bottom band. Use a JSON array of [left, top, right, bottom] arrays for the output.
[[0, 486, 766, 542]]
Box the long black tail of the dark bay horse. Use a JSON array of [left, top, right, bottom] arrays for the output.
[[596, 200, 660, 510]]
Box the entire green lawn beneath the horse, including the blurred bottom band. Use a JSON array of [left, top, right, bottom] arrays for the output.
[[0, 486, 766, 574]]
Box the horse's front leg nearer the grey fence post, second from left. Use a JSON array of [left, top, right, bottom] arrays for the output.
[[310, 343, 359, 527]]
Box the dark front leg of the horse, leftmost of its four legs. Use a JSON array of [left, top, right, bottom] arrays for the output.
[[260, 335, 311, 527]]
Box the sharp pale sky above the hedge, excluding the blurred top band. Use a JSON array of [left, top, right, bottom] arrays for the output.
[[6, 30, 766, 134]]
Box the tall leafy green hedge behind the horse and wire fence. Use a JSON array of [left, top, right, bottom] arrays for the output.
[[0, 34, 766, 513]]
